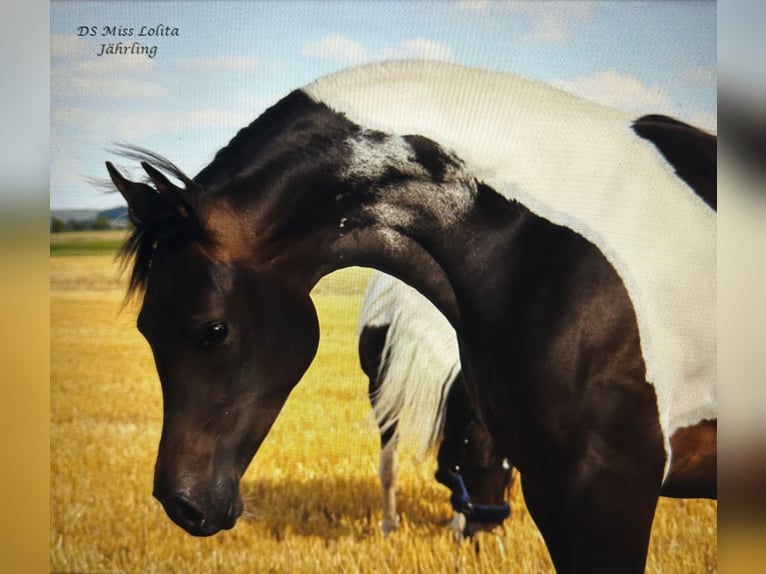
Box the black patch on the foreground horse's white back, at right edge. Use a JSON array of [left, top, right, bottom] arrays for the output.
[[633, 114, 718, 211]]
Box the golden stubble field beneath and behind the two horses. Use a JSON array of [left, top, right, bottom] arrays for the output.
[[50, 241, 717, 574]]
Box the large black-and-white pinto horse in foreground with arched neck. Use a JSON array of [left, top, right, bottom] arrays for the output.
[[107, 61, 717, 573]]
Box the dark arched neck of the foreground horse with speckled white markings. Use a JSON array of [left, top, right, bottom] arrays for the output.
[[200, 116, 519, 332]]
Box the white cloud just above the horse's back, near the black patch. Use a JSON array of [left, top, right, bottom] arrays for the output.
[[556, 70, 672, 114]]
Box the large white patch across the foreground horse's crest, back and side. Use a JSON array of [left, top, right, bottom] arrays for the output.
[[304, 61, 717, 482]]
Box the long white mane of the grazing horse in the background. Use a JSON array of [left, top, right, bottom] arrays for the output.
[[359, 271, 460, 457]]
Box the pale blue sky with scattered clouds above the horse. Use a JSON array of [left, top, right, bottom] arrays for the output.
[[50, 0, 717, 209]]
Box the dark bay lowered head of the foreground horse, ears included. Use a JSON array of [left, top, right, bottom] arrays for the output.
[[108, 155, 326, 536]]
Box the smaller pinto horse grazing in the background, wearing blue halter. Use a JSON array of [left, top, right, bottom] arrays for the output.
[[359, 272, 511, 539]]
